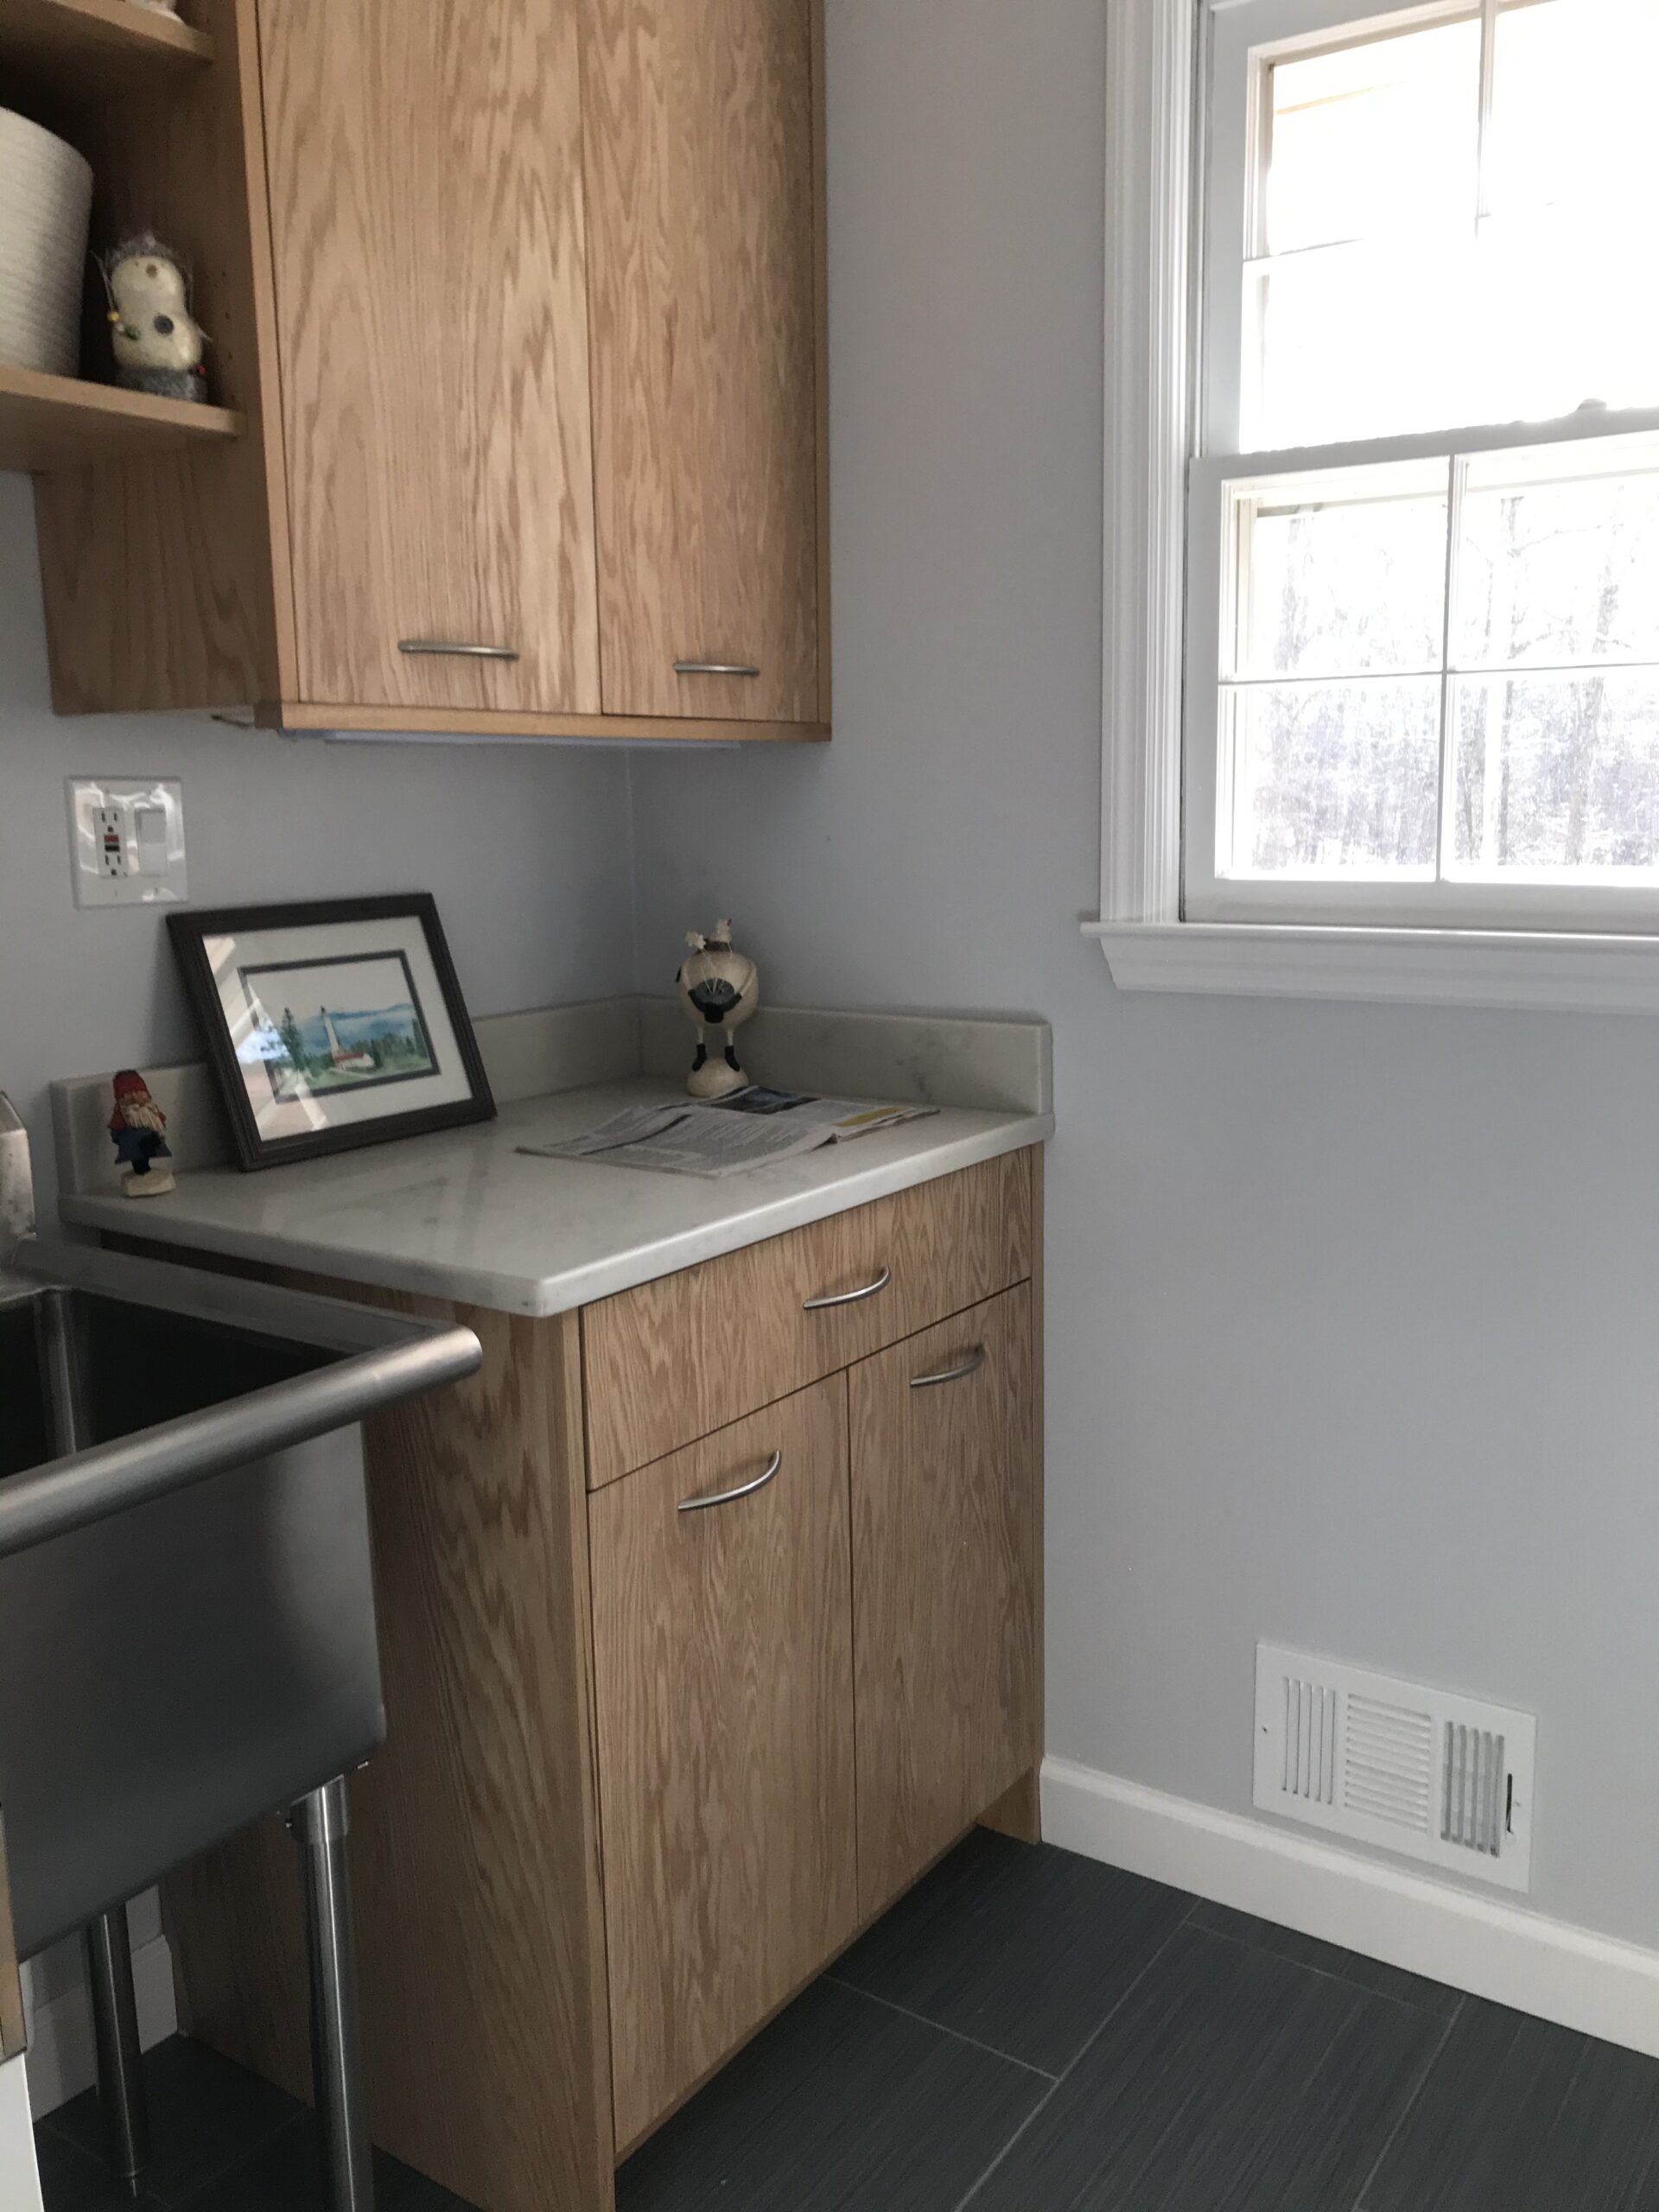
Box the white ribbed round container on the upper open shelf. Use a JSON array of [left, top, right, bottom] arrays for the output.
[[0, 108, 93, 376]]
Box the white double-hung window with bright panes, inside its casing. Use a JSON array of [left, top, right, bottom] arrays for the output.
[[1096, 0, 1659, 1004]]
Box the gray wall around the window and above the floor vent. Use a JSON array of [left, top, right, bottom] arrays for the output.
[[635, 0, 1659, 1944]]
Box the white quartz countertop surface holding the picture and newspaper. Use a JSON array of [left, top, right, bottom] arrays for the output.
[[60, 1075, 1053, 1314]]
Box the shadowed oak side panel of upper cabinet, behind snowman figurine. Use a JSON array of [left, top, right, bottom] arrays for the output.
[[35, 0, 292, 715]]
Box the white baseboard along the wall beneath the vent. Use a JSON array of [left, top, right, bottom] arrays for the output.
[[1042, 1757, 1659, 2057]]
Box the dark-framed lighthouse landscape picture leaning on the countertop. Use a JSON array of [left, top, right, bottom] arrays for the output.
[[168, 892, 495, 1168]]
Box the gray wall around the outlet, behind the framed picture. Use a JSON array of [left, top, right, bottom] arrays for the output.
[[0, 475, 632, 1210]]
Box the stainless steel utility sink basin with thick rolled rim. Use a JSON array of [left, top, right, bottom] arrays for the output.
[[0, 1245, 480, 1958]]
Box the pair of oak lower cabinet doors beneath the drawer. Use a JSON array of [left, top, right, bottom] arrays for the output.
[[588, 1285, 1039, 2152]]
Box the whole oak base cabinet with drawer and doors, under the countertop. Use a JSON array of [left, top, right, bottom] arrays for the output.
[[156, 1154, 1042, 2212]]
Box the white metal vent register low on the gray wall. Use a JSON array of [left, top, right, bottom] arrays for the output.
[[1255, 1643, 1537, 1889]]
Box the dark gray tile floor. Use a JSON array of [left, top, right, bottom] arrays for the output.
[[38, 1832, 1659, 2212]]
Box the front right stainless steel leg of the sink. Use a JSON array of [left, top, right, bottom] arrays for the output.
[[288, 1777, 374, 2212]]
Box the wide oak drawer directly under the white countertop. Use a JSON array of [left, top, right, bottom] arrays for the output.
[[582, 1153, 1031, 1489]]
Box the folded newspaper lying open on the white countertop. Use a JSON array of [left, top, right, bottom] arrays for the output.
[[518, 1084, 938, 1174]]
